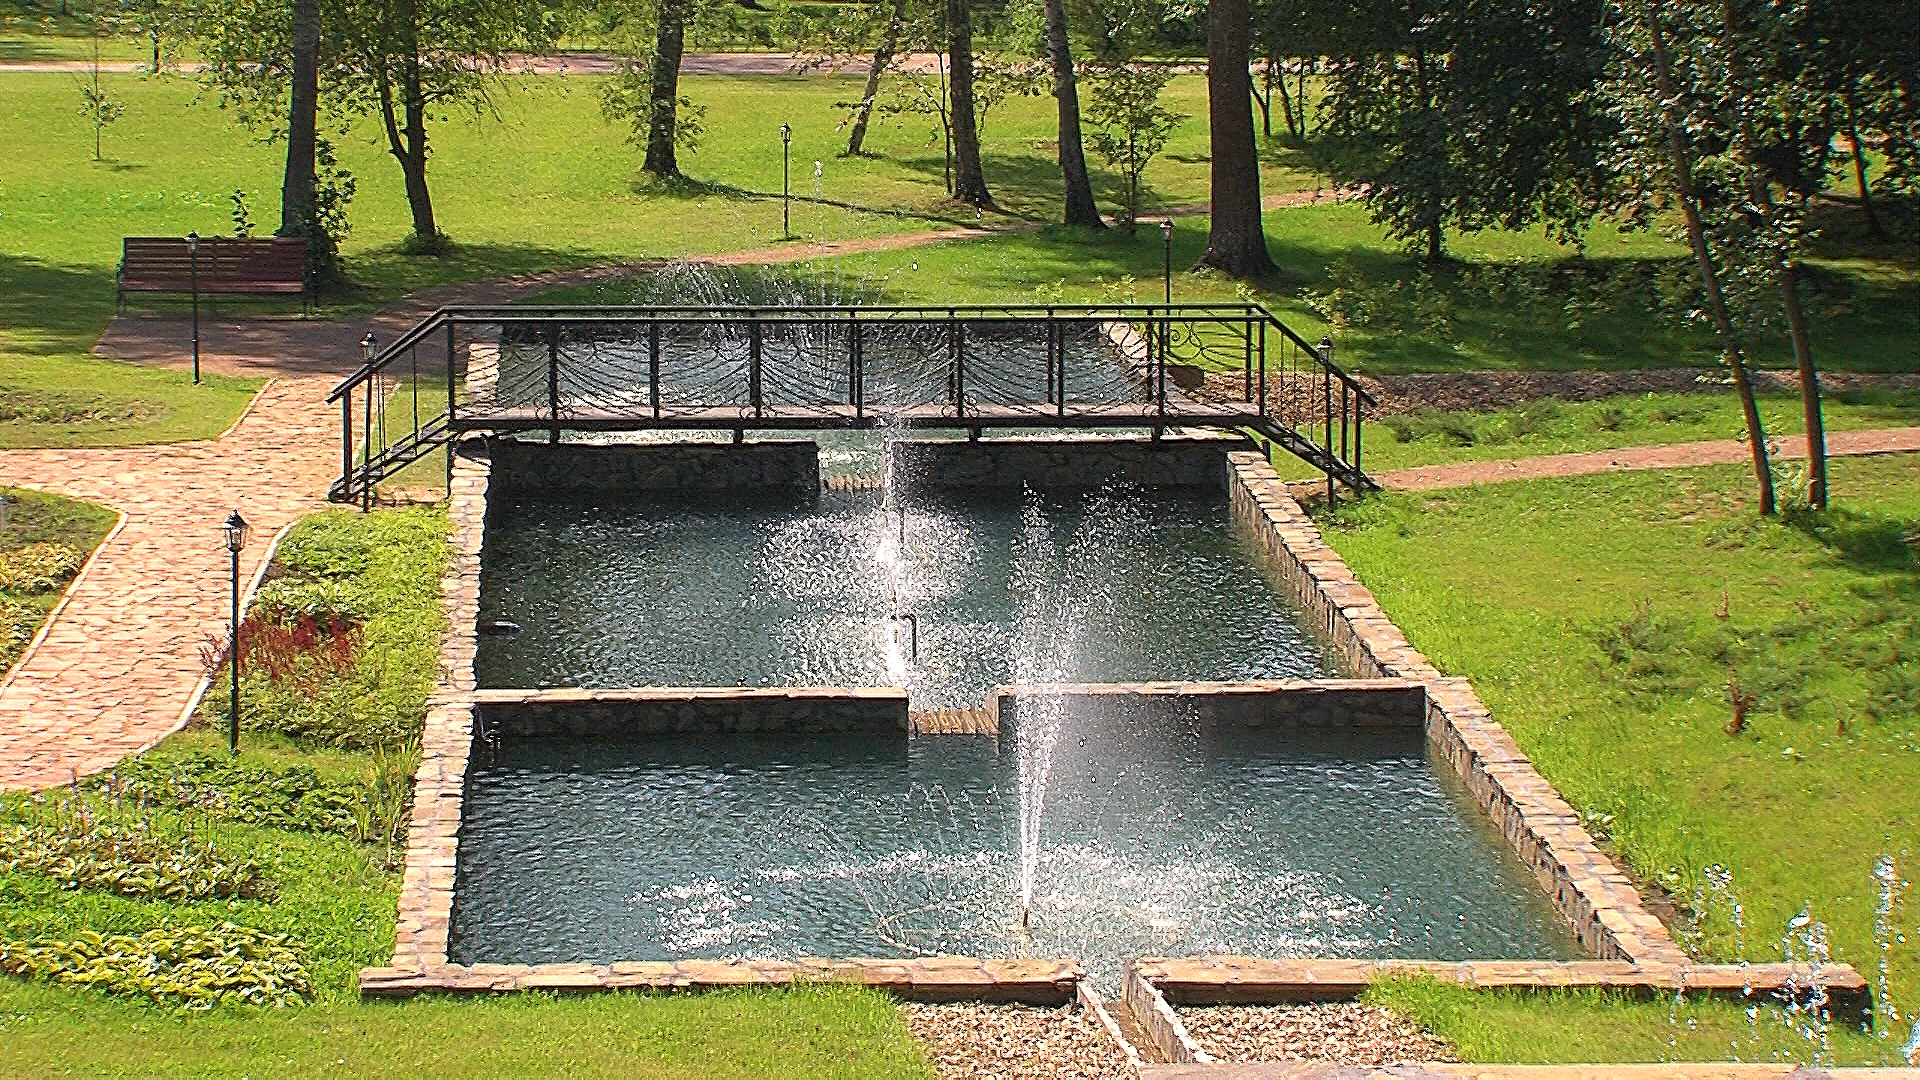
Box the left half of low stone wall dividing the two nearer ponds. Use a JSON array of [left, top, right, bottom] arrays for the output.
[[474, 686, 906, 740]]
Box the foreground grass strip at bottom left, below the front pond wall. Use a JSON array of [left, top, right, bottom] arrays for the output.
[[0, 978, 933, 1080]]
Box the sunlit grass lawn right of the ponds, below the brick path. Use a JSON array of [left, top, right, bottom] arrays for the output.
[[1327, 447, 1920, 1015]]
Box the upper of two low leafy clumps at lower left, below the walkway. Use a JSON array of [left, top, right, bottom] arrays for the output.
[[0, 805, 275, 903]]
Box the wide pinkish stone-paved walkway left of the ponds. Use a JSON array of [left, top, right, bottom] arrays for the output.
[[0, 377, 340, 788]]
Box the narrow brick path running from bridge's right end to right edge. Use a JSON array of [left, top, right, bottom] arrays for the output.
[[1373, 427, 1920, 490]]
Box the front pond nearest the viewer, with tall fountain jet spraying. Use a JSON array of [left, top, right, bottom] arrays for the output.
[[451, 709, 1578, 984]]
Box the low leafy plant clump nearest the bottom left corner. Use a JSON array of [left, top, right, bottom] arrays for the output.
[[0, 922, 313, 1013]]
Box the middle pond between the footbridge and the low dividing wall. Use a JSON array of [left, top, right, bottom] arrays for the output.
[[478, 480, 1327, 709]]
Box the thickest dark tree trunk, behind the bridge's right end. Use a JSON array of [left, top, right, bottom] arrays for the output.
[[1200, 0, 1275, 277]]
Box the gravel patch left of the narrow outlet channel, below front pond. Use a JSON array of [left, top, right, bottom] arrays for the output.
[[900, 1005, 1131, 1080]]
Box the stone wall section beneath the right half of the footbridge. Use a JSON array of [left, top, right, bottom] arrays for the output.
[[891, 434, 1248, 492]]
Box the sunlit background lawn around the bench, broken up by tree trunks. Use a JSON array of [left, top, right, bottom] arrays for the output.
[[0, 73, 1313, 446]]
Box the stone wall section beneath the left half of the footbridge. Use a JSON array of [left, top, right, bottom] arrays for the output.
[[492, 438, 820, 500]]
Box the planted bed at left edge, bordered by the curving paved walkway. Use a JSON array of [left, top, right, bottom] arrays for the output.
[[0, 488, 115, 675]]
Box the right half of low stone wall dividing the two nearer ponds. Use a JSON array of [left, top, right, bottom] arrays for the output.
[[991, 678, 1427, 730]]
